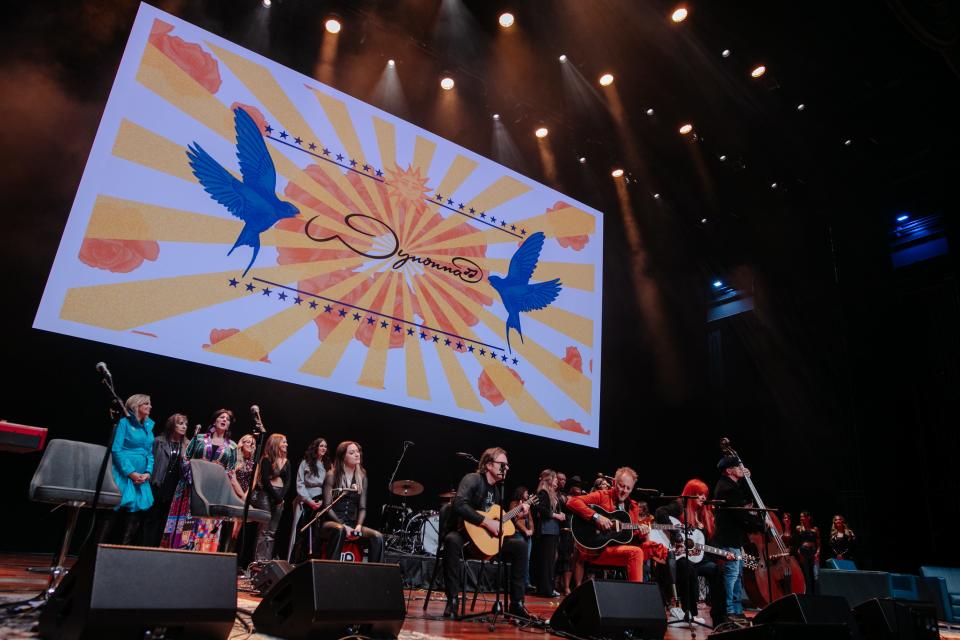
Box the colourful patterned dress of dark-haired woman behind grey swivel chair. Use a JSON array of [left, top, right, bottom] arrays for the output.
[[160, 433, 239, 551]]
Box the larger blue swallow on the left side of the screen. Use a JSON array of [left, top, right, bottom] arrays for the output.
[[187, 107, 300, 277]]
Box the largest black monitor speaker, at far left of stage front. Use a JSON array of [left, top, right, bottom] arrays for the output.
[[39, 544, 237, 640]]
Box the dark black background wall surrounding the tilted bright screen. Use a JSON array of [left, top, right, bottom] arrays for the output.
[[0, 0, 960, 570]]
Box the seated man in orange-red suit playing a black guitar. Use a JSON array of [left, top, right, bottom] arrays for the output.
[[567, 467, 666, 582]]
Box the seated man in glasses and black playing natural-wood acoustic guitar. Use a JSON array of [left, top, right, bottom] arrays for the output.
[[443, 447, 533, 618]]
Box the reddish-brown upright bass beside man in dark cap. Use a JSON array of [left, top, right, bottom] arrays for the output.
[[720, 438, 806, 608]]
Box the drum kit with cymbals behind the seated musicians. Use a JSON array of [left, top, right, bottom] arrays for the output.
[[382, 480, 456, 556]]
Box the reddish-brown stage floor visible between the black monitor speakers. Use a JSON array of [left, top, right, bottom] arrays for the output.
[[0, 554, 960, 640]]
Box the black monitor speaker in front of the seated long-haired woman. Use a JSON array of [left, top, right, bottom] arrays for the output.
[[253, 560, 406, 640]]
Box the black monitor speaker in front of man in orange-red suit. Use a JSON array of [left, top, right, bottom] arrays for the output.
[[550, 580, 667, 640]]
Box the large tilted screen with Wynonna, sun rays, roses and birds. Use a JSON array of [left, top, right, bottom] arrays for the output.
[[34, 5, 603, 447]]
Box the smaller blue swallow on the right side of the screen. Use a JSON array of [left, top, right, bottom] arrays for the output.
[[487, 231, 563, 353]]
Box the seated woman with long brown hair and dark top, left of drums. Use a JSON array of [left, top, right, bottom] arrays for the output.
[[320, 440, 383, 562]]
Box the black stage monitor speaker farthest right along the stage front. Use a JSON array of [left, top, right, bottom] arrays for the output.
[[853, 598, 940, 640]]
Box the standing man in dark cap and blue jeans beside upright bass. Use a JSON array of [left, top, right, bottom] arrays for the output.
[[710, 456, 763, 620]]
